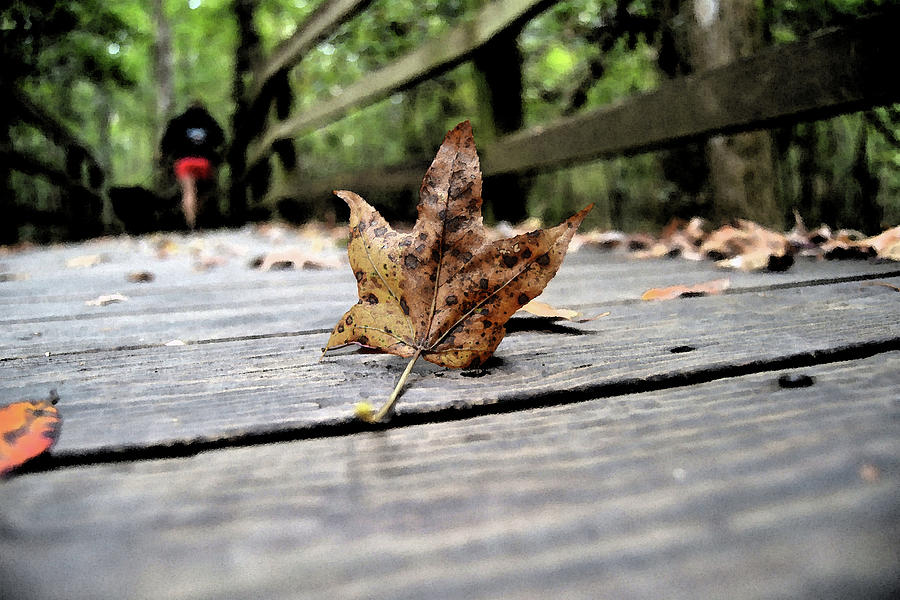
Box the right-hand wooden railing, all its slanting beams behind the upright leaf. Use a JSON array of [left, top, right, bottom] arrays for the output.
[[237, 0, 900, 218]]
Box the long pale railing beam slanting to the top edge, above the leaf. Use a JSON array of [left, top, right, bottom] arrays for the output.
[[247, 0, 556, 165]]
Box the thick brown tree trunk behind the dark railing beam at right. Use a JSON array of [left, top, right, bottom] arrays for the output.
[[683, 0, 784, 228]]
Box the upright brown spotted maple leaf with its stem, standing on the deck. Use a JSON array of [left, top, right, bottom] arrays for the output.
[[325, 121, 593, 421]]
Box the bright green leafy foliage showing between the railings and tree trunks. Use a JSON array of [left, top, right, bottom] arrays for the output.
[[7, 0, 900, 241]]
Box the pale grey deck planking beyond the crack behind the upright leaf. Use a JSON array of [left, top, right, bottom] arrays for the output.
[[0, 233, 900, 358]]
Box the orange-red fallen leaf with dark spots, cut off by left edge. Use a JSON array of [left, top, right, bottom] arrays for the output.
[[0, 390, 62, 477]]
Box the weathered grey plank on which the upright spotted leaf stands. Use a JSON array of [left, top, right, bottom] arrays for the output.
[[0, 278, 900, 457]]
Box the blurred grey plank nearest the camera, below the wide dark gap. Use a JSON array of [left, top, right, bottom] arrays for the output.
[[0, 352, 900, 600]]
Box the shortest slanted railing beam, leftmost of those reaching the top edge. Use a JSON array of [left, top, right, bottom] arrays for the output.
[[249, 0, 371, 100]]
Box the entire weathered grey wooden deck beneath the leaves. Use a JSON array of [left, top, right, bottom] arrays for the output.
[[0, 229, 900, 600]]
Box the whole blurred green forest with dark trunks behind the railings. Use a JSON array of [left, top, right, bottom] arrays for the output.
[[0, 0, 900, 243]]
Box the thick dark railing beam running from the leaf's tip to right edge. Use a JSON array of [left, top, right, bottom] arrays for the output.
[[482, 13, 900, 174]]
